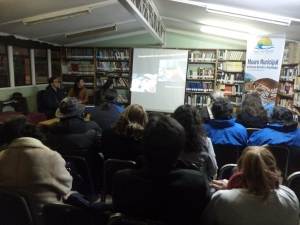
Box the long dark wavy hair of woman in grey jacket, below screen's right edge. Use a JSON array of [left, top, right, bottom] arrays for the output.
[[173, 105, 207, 152]]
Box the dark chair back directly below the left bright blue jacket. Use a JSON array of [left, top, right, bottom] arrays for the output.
[[213, 145, 239, 178]]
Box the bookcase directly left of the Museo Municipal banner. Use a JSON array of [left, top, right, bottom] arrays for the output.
[[216, 49, 246, 107]]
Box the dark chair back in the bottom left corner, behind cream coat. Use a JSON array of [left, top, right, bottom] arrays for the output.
[[0, 190, 33, 225]]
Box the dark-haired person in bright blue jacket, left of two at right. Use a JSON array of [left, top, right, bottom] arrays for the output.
[[204, 98, 248, 149]]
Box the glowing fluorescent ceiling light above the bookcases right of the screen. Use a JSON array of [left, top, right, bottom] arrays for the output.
[[200, 26, 251, 40]]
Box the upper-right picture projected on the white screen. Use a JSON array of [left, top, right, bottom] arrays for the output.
[[158, 59, 186, 81]]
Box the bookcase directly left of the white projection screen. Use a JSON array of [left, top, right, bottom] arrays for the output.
[[95, 48, 132, 106]]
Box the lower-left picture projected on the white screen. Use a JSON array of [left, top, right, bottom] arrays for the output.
[[130, 74, 157, 93]]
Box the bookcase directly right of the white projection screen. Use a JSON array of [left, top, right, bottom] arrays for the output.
[[185, 49, 217, 107]]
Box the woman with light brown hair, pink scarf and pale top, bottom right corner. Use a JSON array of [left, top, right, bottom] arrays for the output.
[[203, 146, 299, 225]]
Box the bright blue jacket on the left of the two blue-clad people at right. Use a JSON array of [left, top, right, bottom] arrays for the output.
[[204, 118, 248, 147]]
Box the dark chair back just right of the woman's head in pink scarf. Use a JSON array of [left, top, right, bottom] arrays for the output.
[[264, 145, 290, 184]]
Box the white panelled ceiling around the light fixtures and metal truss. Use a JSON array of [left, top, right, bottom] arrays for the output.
[[0, 0, 300, 46]]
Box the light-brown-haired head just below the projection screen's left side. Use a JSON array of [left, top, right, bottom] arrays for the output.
[[112, 104, 148, 138]]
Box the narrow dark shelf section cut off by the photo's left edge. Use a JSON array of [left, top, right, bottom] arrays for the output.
[[0, 44, 9, 88]]
